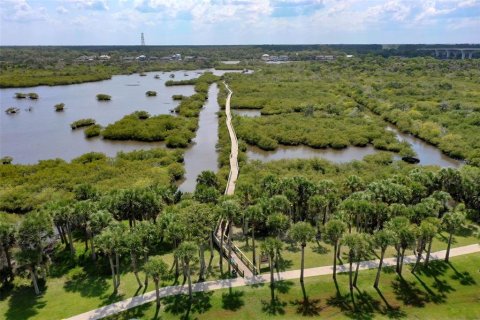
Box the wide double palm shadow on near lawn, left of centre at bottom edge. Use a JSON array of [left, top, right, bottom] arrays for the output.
[[163, 292, 213, 319]]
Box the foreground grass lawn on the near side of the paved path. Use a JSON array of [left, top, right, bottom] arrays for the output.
[[105, 253, 480, 320]]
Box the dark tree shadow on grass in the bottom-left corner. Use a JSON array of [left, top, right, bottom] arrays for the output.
[[2, 281, 46, 320]]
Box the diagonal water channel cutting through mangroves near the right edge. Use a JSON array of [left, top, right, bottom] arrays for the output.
[[386, 124, 463, 168]]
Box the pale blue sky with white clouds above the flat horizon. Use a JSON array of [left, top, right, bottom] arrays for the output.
[[0, 0, 480, 45]]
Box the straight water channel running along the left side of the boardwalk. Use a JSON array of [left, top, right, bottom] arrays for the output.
[[180, 84, 220, 192]]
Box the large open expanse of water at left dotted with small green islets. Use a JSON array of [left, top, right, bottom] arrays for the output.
[[0, 71, 202, 164]]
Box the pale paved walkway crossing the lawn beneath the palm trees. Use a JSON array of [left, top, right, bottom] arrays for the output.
[[65, 244, 480, 320]]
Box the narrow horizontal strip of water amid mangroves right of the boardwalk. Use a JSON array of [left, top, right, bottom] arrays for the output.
[[247, 146, 377, 163]]
